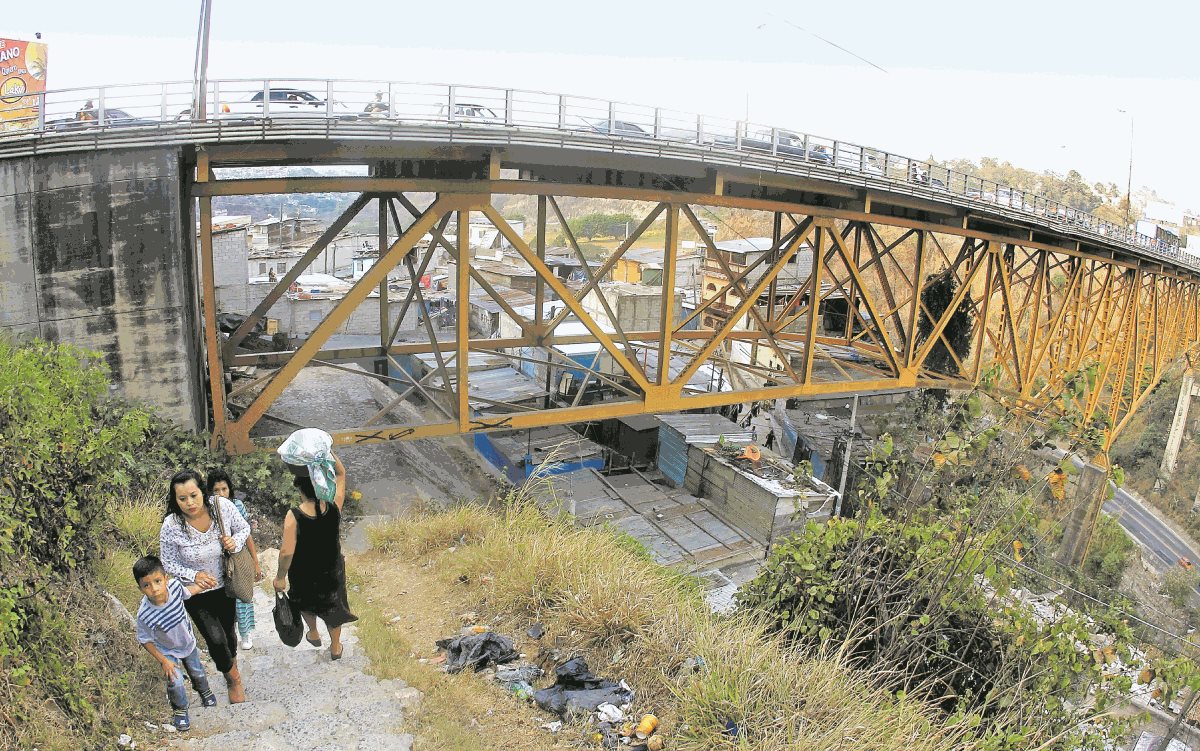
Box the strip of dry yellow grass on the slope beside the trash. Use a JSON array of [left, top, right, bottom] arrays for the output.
[[371, 491, 972, 751]]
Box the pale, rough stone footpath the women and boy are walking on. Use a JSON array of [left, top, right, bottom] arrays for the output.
[[168, 551, 421, 751]]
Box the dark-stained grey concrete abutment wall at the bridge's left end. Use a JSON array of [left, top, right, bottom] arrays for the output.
[[0, 149, 204, 427]]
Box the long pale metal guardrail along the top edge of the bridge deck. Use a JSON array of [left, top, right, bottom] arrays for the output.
[[0, 78, 1200, 271]]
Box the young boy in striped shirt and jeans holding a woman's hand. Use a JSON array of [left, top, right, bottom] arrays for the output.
[[133, 555, 217, 731]]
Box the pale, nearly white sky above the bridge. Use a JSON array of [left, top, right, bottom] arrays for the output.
[[9, 0, 1200, 211]]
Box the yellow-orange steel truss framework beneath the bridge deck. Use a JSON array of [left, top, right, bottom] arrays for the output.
[[192, 170, 1200, 451]]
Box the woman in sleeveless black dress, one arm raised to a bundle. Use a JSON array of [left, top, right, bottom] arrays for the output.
[[274, 456, 358, 660]]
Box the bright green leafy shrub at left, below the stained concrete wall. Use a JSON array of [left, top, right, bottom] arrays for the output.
[[0, 337, 150, 731]]
